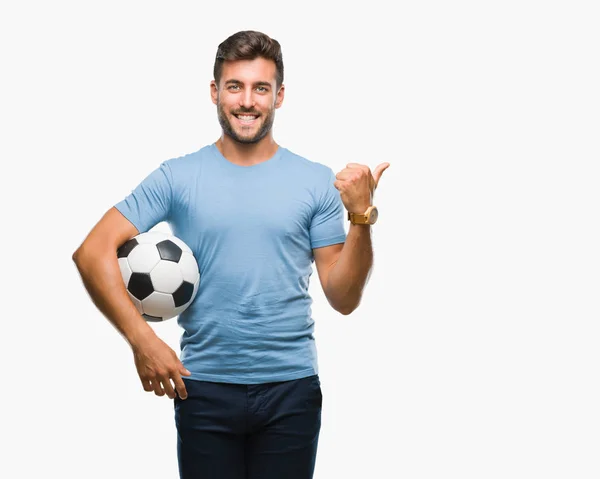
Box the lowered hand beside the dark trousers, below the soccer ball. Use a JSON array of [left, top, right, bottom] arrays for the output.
[[132, 336, 192, 399]]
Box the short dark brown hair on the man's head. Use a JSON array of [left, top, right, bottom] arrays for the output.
[[213, 30, 283, 89]]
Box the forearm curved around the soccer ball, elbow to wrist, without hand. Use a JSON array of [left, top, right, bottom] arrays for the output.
[[73, 251, 155, 347]]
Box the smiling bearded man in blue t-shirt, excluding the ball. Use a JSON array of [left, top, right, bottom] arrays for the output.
[[73, 31, 389, 479]]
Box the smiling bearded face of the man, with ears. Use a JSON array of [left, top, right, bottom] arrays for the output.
[[211, 58, 284, 143]]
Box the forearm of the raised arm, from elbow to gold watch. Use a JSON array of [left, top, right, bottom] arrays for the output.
[[325, 224, 373, 314]]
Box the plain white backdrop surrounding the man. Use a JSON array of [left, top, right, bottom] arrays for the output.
[[0, 0, 600, 479]]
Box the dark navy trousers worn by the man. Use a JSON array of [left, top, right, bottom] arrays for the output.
[[174, 375, 323, 479]]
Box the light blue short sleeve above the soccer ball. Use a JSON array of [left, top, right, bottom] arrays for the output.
[[115, 162, 173, 233]]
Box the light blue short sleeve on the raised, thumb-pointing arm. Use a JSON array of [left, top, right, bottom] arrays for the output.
[[310, 168, 346, 248]]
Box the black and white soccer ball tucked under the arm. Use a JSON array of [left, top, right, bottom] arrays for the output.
[[117, 231, 200, 322]]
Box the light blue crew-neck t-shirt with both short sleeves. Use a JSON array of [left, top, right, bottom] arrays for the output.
[[115, 144, 346, 384]]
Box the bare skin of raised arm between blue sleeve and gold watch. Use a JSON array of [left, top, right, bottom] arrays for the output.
[[313, 224, 373, 315]]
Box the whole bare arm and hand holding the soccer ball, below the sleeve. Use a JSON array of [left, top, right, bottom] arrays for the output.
[[73, 207, 190, 399]]
